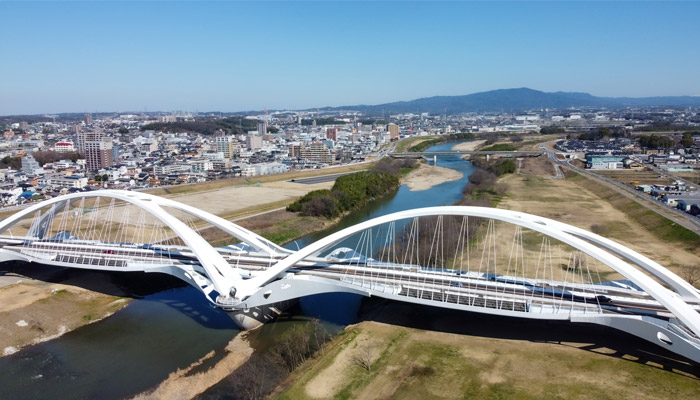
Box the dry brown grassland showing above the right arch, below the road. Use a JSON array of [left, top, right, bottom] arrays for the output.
[[498, 157, 700, 279]]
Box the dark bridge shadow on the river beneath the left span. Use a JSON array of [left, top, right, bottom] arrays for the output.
[[0, 262, 237, 330]]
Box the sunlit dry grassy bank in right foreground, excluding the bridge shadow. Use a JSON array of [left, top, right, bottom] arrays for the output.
[[278, 320, 700, 400]]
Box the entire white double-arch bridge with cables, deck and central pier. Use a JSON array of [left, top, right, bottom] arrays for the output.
[[0, 190, 700, 362]]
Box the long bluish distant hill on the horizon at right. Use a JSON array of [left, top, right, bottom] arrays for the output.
[[324, 88, 700, 114]]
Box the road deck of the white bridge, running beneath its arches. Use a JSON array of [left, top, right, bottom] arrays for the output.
[[0, 237, 688, 319]]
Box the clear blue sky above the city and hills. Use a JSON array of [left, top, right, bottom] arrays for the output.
[[0, 1, 700, 115]]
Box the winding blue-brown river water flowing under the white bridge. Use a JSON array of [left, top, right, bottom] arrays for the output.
[[0, 143, 473, 399]]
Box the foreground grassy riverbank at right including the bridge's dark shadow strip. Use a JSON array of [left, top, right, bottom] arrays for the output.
[[270, 300, 700, 400]]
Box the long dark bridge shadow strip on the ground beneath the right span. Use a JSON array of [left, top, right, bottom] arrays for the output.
[[359, 298, 700, 380]]
